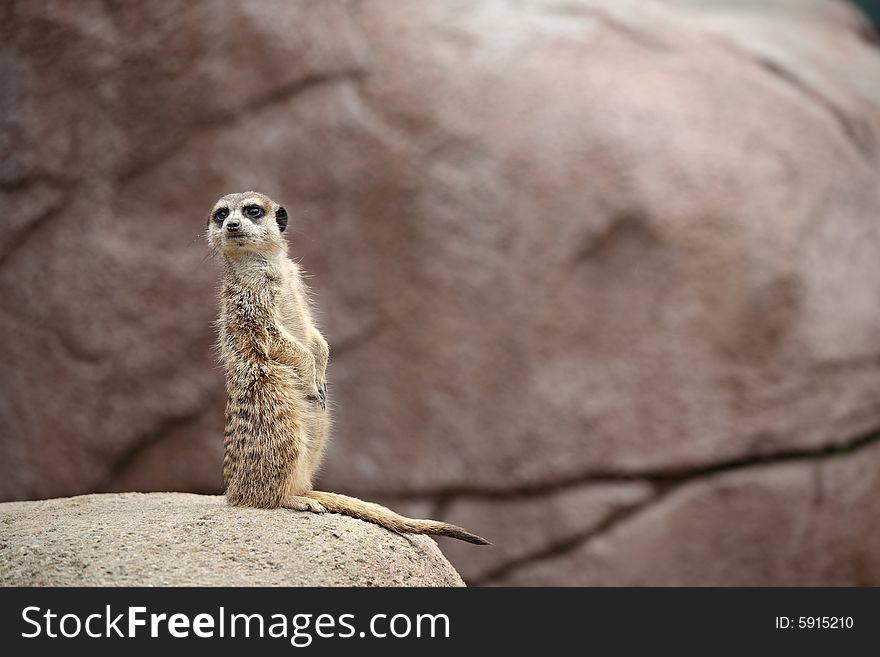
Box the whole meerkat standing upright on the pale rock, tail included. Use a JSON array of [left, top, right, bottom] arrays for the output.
[[207, 192, 488, 545]]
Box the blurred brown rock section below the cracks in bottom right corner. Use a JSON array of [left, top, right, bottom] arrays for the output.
[[496, 436, 880, 586]]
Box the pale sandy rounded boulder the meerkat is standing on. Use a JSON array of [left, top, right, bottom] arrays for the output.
[[0, 493, 463, 586]]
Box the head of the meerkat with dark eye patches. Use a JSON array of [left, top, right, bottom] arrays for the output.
[[208, 192, 287, 258]]
